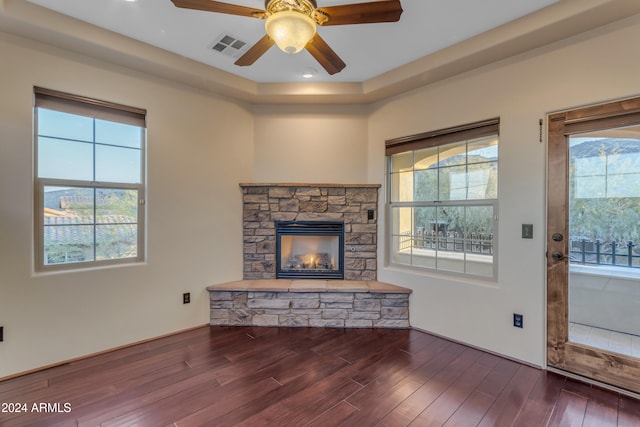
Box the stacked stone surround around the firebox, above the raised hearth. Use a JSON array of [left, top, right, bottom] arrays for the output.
[[240, 184, 380, 280]]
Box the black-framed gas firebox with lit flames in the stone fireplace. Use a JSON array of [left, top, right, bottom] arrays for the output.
[[276, 221, 344, 280]]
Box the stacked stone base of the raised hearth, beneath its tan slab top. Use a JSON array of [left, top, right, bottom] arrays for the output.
[[208, 281, 411, 328]]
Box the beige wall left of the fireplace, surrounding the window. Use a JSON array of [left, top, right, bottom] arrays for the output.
[[0, 36, 253, 378]]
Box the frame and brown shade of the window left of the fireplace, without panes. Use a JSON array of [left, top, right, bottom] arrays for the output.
[[33, 86, 147, 272]]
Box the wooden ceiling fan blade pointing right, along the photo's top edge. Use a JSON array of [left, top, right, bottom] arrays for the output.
[[316, 0, 402, 26]]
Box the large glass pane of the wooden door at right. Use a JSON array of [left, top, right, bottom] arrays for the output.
[[568, 130, 640, 357]]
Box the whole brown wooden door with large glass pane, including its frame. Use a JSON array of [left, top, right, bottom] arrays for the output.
[[547, 98, 640, 393]]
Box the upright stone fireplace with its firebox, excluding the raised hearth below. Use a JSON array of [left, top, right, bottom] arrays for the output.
[[240, 183, 380, 280]]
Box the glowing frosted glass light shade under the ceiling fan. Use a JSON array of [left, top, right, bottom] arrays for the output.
[[264, 10, 316, 54]]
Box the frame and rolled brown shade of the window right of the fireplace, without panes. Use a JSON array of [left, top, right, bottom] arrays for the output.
[[385, 118, 500, 283]]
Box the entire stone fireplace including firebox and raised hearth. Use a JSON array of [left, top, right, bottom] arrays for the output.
[[207, 183, 411, 328]]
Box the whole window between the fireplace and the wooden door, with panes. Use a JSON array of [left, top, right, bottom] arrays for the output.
[[386, 119, 499, 279]]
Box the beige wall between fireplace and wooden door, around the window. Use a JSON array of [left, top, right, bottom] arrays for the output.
[[368, 16, 640, 365]]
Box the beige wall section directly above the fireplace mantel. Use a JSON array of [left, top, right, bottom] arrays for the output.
[[253, 105, 367, 184]]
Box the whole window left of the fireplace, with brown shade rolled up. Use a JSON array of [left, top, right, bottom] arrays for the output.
[[34, 87, 146, 271]]
